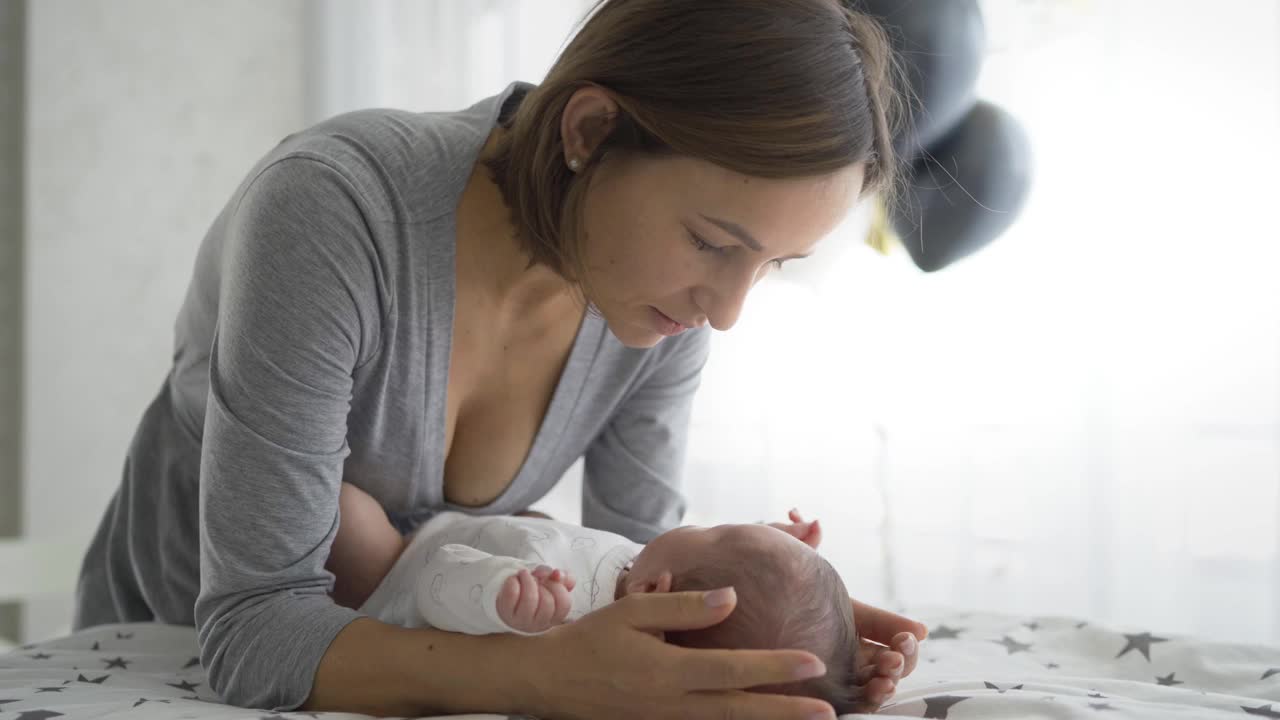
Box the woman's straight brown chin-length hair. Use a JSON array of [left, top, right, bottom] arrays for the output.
[[486, 0, 905, 293]]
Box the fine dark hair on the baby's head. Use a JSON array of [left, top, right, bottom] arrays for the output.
[[666, 535, 864, 715]]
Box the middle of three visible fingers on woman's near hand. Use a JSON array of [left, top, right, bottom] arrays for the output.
[[672, 650, 827, 691]]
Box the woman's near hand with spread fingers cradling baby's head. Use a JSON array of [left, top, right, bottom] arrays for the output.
[[526, 589, 836, 720]]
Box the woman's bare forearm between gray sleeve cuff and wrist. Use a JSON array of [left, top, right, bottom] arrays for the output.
[[302, 618, 538, 717]]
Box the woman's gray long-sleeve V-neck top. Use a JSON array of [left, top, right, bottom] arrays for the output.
[[74, 83, 709, 710]]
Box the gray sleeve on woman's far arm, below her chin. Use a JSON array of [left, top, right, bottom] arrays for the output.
[[582, 328, 710, 543]]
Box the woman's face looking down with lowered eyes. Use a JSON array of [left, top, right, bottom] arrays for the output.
[[584, 155, 863, 347]]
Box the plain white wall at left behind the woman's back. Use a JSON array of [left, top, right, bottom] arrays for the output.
[[24, 0, 306, 638]]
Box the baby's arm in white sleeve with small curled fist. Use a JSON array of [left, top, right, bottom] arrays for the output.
[[416, 544, 573, 635]]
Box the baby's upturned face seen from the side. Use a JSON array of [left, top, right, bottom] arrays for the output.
[[620, 524, 814, 597]]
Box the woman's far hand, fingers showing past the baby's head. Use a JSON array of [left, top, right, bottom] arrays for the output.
[[850, 598, 929, 712]]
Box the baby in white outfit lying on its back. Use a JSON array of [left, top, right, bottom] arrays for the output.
[[328, 483, 870, 714]]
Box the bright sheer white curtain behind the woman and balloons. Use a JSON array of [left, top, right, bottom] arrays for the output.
[[316, 0, 1280, 642]]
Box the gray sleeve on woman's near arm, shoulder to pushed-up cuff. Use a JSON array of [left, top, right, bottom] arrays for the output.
[[196, 156, 381, 711]]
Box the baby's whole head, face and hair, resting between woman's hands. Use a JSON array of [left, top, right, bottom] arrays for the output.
[[618, 524, 869, 714]]
